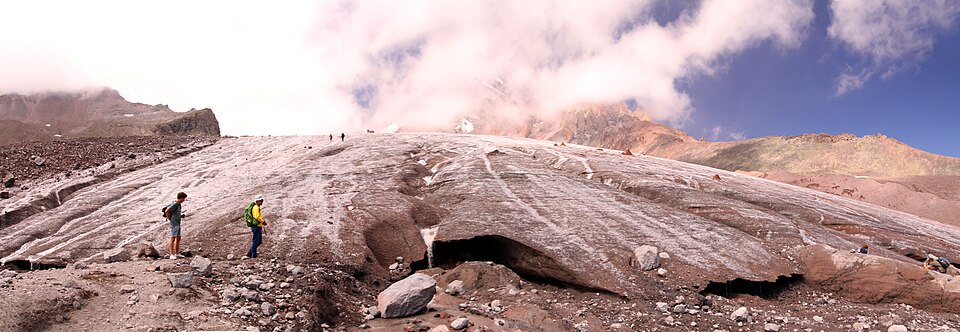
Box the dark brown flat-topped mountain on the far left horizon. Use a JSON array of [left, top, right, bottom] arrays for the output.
[[0, 88, 220, 145]]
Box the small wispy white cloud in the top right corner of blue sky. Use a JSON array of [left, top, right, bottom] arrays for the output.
[[828, 0, 960, 95]]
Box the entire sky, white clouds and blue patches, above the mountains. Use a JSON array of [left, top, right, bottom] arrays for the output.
[[0, 0, 960, 157]]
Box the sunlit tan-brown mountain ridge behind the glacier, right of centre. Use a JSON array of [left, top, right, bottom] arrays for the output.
[[464, 104, 960, 177]]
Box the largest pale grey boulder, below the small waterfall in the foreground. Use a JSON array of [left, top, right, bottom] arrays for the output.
[[377, 273, 437, 318]]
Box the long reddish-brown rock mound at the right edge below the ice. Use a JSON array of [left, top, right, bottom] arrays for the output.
[[798, 244, 960, 312]]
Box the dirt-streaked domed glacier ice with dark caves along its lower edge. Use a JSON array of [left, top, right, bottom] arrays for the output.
[[0, 133, 960, 295]]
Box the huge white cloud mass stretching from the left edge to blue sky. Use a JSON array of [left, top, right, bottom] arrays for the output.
[[0, 0, 813, 134]]
